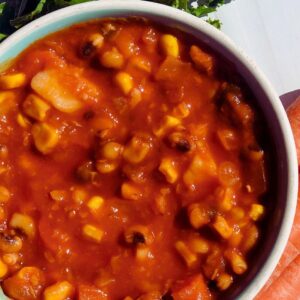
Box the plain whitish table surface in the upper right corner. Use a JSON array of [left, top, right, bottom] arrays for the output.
[[214, 0, 300, 95]]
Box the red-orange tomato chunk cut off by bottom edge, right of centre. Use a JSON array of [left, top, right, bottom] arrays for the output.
[[172, 274, 211, 300]]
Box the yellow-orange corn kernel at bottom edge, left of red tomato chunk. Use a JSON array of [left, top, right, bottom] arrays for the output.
[[44, 281, 74, 300]]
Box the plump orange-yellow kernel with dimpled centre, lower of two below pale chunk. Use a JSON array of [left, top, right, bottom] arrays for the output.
[[31, 123, 59, 154]]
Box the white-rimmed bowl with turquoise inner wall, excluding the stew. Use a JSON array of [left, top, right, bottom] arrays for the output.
[[0, 0, 298, 299]]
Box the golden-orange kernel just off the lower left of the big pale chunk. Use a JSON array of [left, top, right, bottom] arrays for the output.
[[23, 94, 50, 121]]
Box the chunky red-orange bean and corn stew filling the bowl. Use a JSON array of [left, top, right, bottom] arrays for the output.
[[0, 19, 271, 300]]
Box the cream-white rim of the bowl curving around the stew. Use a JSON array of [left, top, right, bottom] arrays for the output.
[[0, 0, 298, 300]]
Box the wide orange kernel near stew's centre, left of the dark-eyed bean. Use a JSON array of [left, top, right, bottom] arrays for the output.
[[123, 136, 151, 164]]
